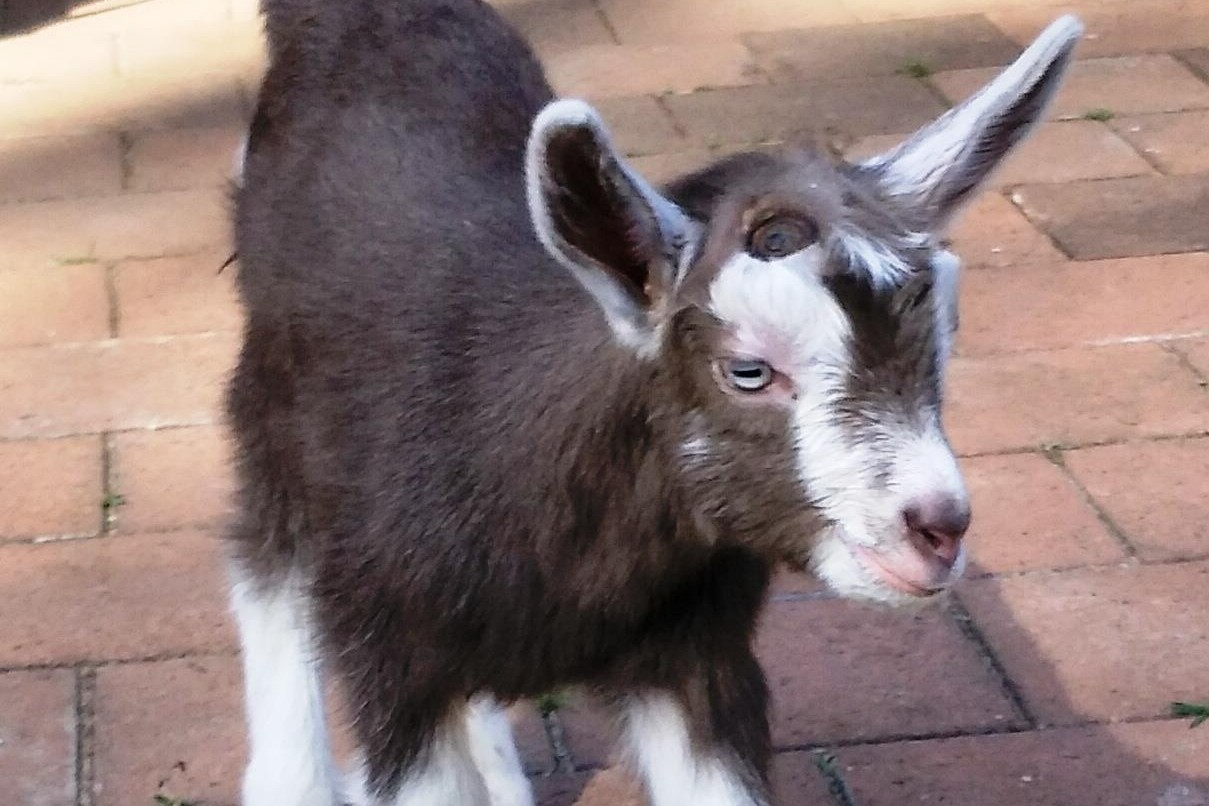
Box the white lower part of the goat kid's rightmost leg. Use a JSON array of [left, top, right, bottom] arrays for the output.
[[626, 694, 767, 806]]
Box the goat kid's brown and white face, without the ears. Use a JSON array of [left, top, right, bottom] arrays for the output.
[[655, 153, 970, 599]]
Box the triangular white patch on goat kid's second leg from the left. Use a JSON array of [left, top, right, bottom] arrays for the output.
[[388, 713, 491, 806]]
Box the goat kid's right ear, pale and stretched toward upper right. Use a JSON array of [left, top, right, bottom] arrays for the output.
[[861, 16, 1083, 228]]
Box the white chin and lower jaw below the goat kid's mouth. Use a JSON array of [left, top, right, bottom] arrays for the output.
[[810, 530, 947, 607]]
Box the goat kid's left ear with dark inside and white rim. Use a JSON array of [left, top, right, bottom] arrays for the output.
[[525, 100, 694, 347]]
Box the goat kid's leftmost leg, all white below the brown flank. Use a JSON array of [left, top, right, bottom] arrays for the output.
[[231, 570, 336, 806]]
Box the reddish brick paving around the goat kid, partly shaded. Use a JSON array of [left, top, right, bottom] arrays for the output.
[[0, 0, 1209, 806]]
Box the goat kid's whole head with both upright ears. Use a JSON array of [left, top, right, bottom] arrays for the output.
[[527, 17, 1081, 602]]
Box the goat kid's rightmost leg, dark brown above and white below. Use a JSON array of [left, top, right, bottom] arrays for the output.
[[623, 648, 771, 806]]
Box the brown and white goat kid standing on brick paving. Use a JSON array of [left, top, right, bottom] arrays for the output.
[[229, 0, 1080, 806]]
